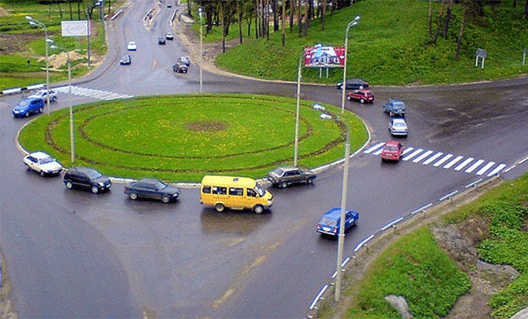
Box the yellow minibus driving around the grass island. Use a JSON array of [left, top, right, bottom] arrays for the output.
[[200, 175, 273, 214]]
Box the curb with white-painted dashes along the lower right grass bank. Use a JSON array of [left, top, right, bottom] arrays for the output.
[[307, 170, 510, 318]]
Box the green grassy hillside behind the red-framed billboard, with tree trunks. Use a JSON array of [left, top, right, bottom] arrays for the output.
[[212, 0, 528, 85]]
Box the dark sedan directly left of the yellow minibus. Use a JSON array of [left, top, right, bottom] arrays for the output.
[[125, 178, 181, 203]]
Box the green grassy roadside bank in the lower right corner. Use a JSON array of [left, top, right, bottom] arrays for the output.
[[317, 174, 528, 319]]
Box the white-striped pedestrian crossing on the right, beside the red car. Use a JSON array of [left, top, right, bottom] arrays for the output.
[[363, 142, 506, 177]]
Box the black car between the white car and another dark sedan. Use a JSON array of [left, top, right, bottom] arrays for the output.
[[63, 167, 112, 194]]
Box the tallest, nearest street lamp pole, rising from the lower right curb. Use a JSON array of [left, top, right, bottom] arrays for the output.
[[334, 16, 359, 301]]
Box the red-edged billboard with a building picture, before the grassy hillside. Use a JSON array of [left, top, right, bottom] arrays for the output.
[[304, 44, 345, 68]]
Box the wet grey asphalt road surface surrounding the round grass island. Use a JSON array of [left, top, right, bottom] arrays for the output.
[[0, 1, 528, 318]]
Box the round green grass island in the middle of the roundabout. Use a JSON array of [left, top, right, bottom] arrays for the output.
[[19, 94, 367, 182]]
